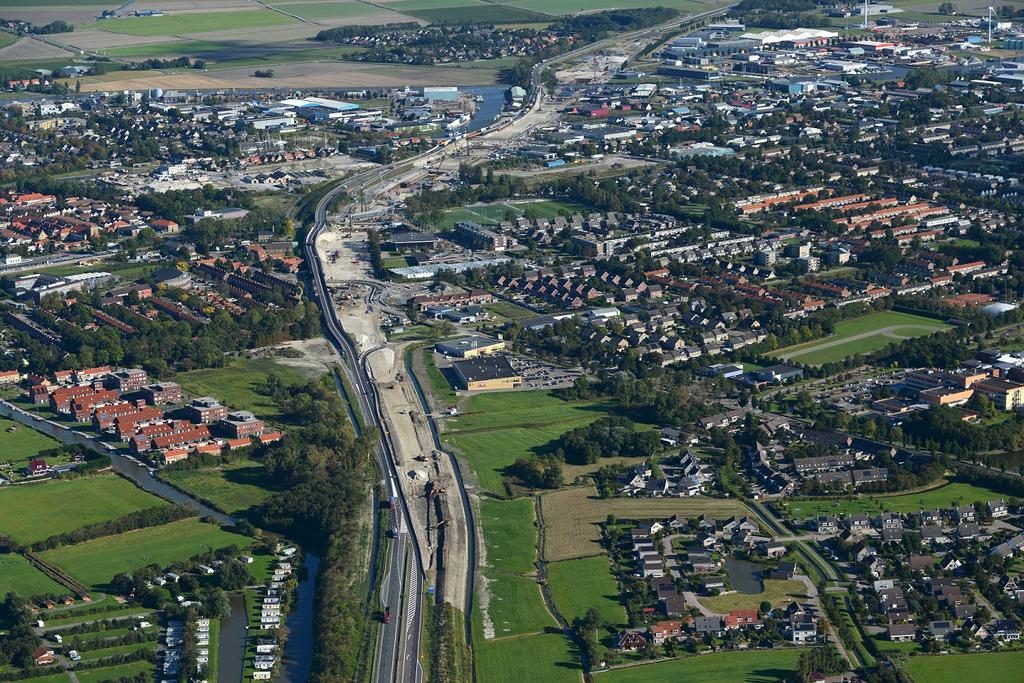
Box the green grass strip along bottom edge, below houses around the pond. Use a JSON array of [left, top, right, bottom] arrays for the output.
[[601, 648, 800, 683]]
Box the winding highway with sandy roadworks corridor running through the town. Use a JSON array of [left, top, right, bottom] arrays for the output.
[[303, 6, 728, 683]]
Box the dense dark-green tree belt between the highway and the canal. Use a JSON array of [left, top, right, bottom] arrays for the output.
[[249, 376, 376, 683]]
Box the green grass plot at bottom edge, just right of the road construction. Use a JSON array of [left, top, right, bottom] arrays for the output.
[[473, 633, 582, 683]]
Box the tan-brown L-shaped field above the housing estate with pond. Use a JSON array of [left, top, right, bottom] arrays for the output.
[[540, 486, 749, 561]]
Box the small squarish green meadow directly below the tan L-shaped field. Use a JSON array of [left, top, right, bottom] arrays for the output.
[[548, 555, 627, 626]]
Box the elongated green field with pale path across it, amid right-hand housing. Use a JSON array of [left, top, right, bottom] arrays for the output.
[[773, 310, 950, 366]]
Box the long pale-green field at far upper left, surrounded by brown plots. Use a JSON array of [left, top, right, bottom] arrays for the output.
[[87, 9, 299, 36]]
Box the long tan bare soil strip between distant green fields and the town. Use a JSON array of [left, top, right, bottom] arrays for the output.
[[72, 61, 496, 92]]
